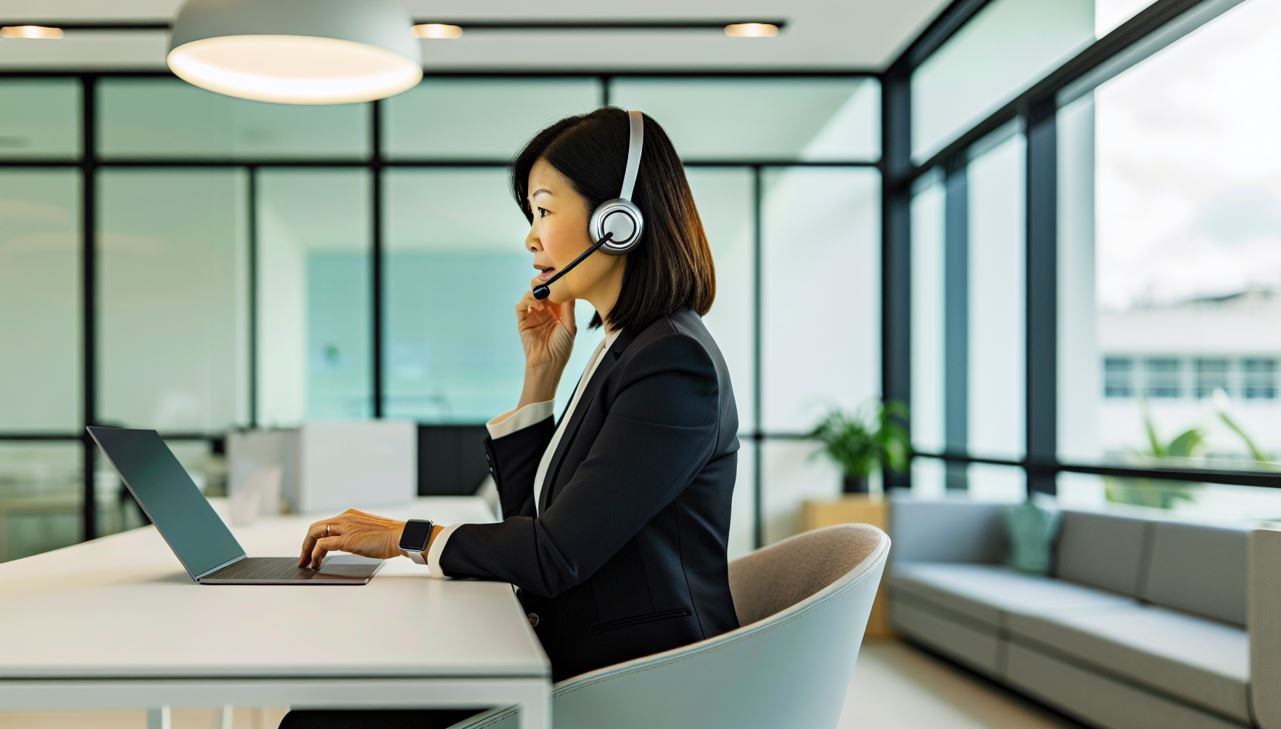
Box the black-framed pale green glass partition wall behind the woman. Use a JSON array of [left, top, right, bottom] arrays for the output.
[[0, 74, 880, 559]]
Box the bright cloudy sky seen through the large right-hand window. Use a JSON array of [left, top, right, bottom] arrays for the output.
[[1094, 0, 1281, 310]]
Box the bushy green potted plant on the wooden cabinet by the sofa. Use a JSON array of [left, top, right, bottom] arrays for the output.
[[810, 400, 911, 493]]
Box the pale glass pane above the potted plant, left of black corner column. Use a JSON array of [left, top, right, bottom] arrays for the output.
[[760, 168, 880, 435]]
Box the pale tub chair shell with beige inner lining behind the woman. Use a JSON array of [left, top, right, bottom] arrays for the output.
[[545, 524, 889, 729]]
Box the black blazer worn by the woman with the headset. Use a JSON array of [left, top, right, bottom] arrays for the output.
[[441, 303, 739, 680]]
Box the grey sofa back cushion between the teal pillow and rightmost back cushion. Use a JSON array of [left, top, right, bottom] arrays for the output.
[[1054, 510, 1150, 596]]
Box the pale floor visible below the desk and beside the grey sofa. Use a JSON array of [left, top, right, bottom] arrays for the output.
[[0, 642, 1076, 729]]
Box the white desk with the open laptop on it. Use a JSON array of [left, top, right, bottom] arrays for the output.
[[0, 497, 551, 729]]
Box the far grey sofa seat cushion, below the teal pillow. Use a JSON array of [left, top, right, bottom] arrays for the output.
[[889, 562, 1135, 625]]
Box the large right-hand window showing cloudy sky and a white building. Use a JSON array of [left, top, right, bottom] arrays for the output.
[[1057, 0, 1281, 476]]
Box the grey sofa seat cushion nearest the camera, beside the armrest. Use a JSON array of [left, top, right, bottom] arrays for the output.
[[1006, 605, 1250, 724]]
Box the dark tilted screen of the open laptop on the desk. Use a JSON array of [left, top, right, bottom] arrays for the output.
[[88, 428, 245, 579]]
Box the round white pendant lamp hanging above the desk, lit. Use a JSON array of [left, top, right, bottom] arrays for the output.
[[165, 0, 423, 104]]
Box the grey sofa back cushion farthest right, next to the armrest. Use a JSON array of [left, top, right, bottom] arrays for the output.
[[1143, 521, 1250, 625]]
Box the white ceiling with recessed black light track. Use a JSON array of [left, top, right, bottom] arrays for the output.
[[0, 0, 947, 73]]
